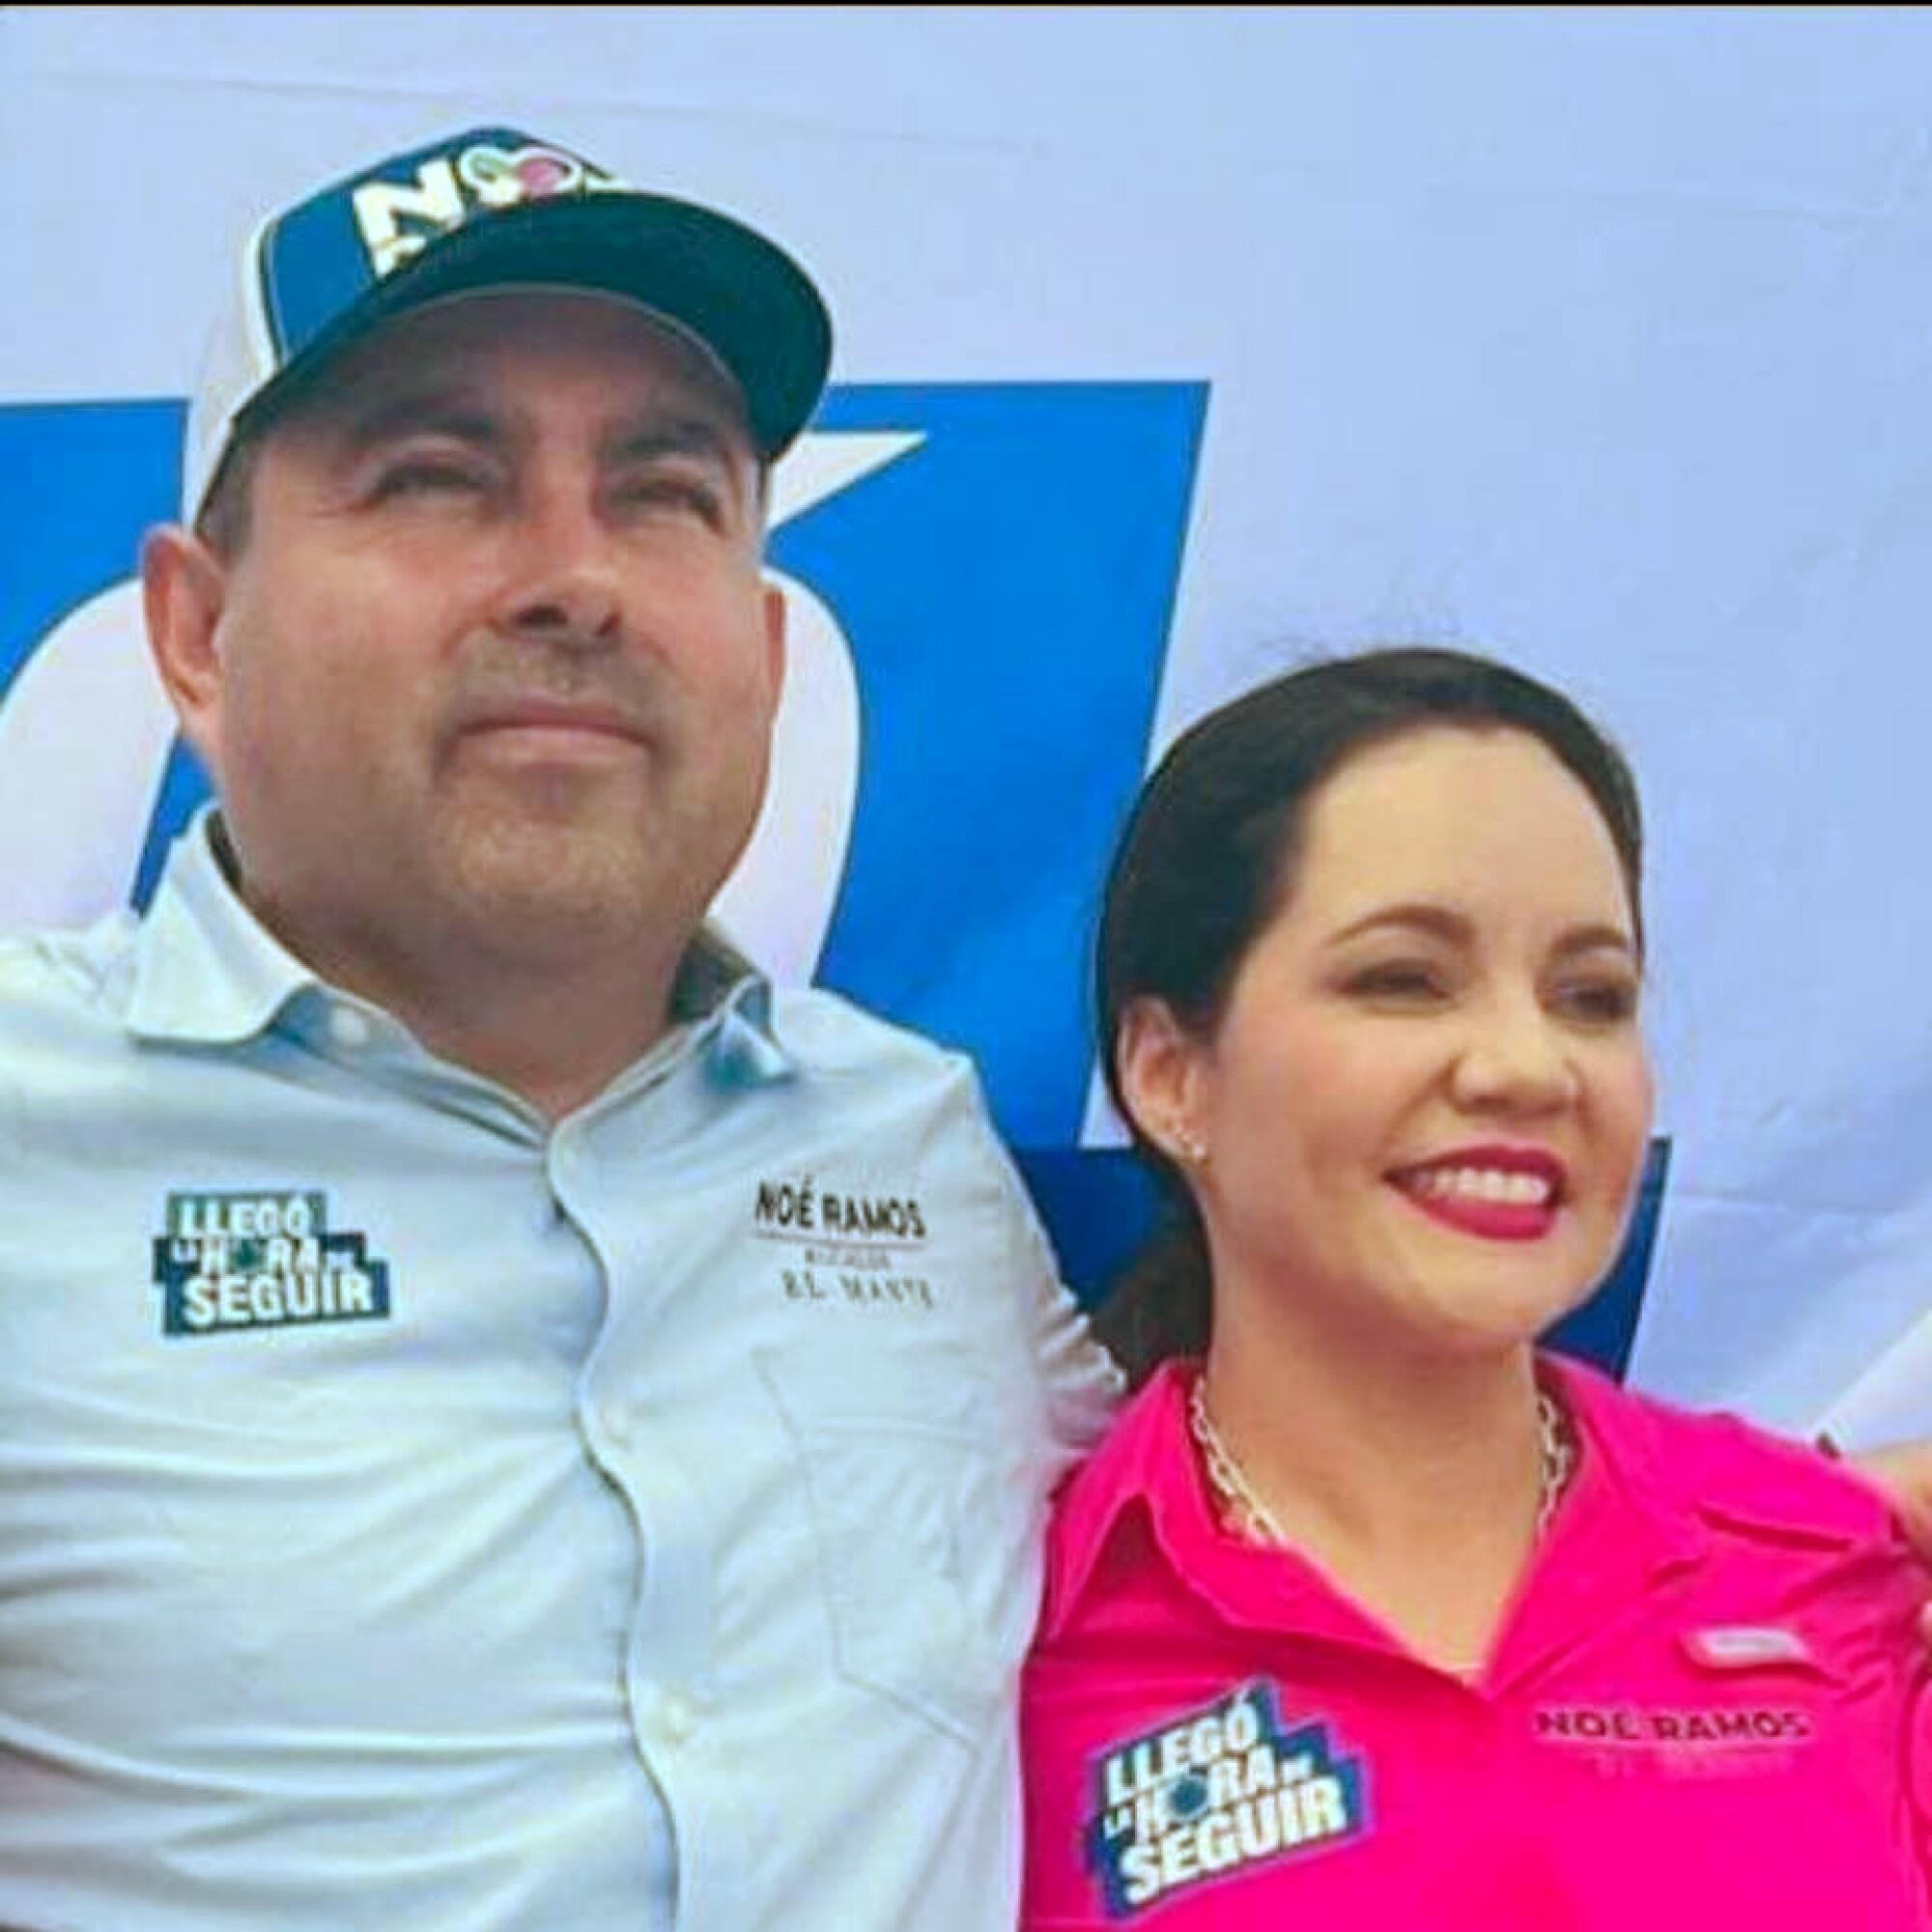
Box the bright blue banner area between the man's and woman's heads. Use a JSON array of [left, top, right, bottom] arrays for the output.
[[773, 383, 1208, 1146]]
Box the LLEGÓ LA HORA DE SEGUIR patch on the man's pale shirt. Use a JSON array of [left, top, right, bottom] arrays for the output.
[[155, 1188, 388, 1337]]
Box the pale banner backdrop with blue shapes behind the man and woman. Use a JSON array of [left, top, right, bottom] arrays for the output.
[[0, 8, 1932, 1435]]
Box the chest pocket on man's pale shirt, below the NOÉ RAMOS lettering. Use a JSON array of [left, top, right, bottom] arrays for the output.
[[755, 1349, 1020, 1745]]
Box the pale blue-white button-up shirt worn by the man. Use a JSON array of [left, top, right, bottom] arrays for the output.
[[0, 821, 1115, 1932]]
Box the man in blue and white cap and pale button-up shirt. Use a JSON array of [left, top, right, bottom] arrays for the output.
[[0, 129, 1113, 1932]]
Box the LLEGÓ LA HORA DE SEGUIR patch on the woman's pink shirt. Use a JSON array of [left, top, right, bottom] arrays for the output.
[[1086, 1681, 1368, 1918]]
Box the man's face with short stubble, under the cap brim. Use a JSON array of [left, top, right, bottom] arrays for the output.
[[151, 294, 782, 970]]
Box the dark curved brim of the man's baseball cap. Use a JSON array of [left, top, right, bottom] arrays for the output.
[[242, 189, 831, 462]]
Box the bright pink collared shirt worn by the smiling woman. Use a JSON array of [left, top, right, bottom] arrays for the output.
[[1022, 1360, 1932, 1932]]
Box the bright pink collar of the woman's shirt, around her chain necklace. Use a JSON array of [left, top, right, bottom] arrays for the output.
[[1041, 1356, 1710, 1648]]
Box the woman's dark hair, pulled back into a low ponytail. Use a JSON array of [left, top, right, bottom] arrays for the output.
[[1095, 649, 1644, 1383]]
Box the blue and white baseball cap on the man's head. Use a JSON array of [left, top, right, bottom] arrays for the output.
[[182, 128, 831, 520]]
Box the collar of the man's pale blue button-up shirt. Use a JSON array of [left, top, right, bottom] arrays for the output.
[[126, 808, 792, 1086]]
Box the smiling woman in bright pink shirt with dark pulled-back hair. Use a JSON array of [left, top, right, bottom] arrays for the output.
[[1024, 651, 1932, 1932]]
